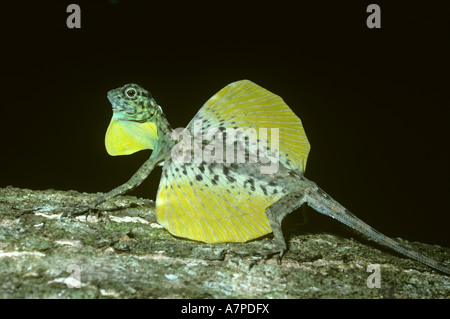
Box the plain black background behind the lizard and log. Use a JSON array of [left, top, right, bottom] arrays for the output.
[[0, 0, 450, 246]]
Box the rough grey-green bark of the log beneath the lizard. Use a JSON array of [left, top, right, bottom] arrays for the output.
[[0, 187, 450, 298]]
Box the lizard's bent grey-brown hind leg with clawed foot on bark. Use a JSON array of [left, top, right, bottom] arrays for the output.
[[264, 193, 305, 263]]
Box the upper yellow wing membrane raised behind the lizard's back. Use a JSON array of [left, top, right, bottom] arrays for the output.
[[188, 80, 310, 172]]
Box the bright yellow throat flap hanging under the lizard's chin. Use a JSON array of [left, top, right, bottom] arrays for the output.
[[105, 116, 158, 156]]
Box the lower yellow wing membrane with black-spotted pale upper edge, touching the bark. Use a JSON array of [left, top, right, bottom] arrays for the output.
[[156, 162, 282, 243]]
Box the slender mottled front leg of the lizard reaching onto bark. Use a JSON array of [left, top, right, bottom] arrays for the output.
[[61, 152, 161, 218]]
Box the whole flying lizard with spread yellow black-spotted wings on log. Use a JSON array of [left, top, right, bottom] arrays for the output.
[[62, 80, 450, 274]]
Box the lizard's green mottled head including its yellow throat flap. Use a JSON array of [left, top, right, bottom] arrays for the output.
[[105, 84, 164, 156]]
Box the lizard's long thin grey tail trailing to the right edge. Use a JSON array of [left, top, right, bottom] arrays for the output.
[[306, 182, 450, 275]]
